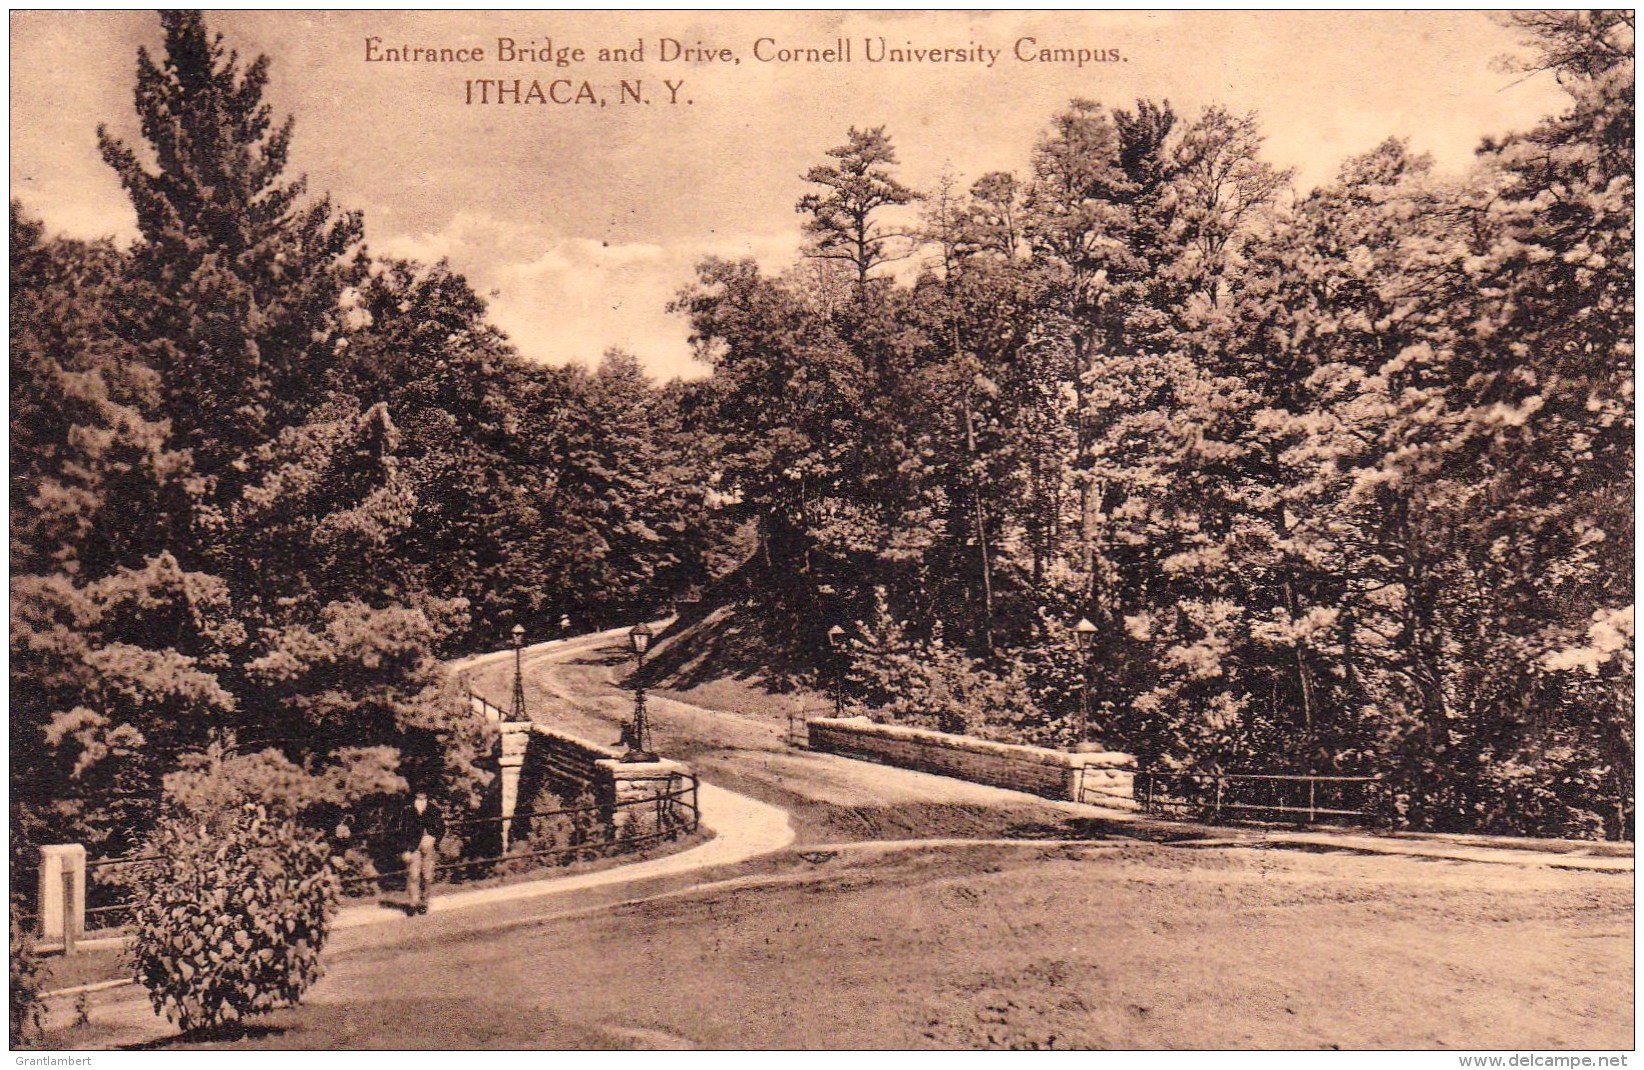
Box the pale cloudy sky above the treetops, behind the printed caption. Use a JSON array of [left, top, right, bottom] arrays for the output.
[[10, 12, 1562, 376]]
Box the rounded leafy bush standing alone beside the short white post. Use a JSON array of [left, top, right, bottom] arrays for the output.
[[133, 805, 339, 1032]]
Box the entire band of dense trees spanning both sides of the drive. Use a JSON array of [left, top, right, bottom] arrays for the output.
[[12, 13, 1634, 850]]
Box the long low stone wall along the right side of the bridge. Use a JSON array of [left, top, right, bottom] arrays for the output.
[[806, 717, 1136, 809]]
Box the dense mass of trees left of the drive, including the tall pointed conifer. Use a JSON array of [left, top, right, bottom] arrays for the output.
[[12, 13, 722, 853]]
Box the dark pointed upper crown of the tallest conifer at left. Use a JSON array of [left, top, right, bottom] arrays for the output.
[[99, 12, 362, 493]]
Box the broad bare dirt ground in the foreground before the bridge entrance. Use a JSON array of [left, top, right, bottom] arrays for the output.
[[96, 843, 1634, 1049]]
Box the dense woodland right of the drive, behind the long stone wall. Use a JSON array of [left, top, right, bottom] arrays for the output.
[[676, 13, 1634, 837]]
